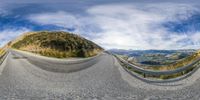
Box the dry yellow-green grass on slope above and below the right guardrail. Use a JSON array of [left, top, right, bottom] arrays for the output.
[[120, 51, 200, 79]]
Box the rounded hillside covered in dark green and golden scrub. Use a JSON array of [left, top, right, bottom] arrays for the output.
[[11, 31, 103, 58]]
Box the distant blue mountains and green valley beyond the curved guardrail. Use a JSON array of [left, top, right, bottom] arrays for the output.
[[109, 49, 197, 65]]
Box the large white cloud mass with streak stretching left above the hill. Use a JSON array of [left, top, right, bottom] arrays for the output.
[[26, 3, 200, 49]]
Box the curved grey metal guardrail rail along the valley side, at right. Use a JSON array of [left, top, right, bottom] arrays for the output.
[[114, 55, 200, 76]]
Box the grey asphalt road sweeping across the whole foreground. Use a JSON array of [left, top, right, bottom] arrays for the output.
[[0, 50, 200, 100]]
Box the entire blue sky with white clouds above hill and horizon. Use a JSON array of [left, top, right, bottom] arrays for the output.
[[0, 0, 200, 50]]
